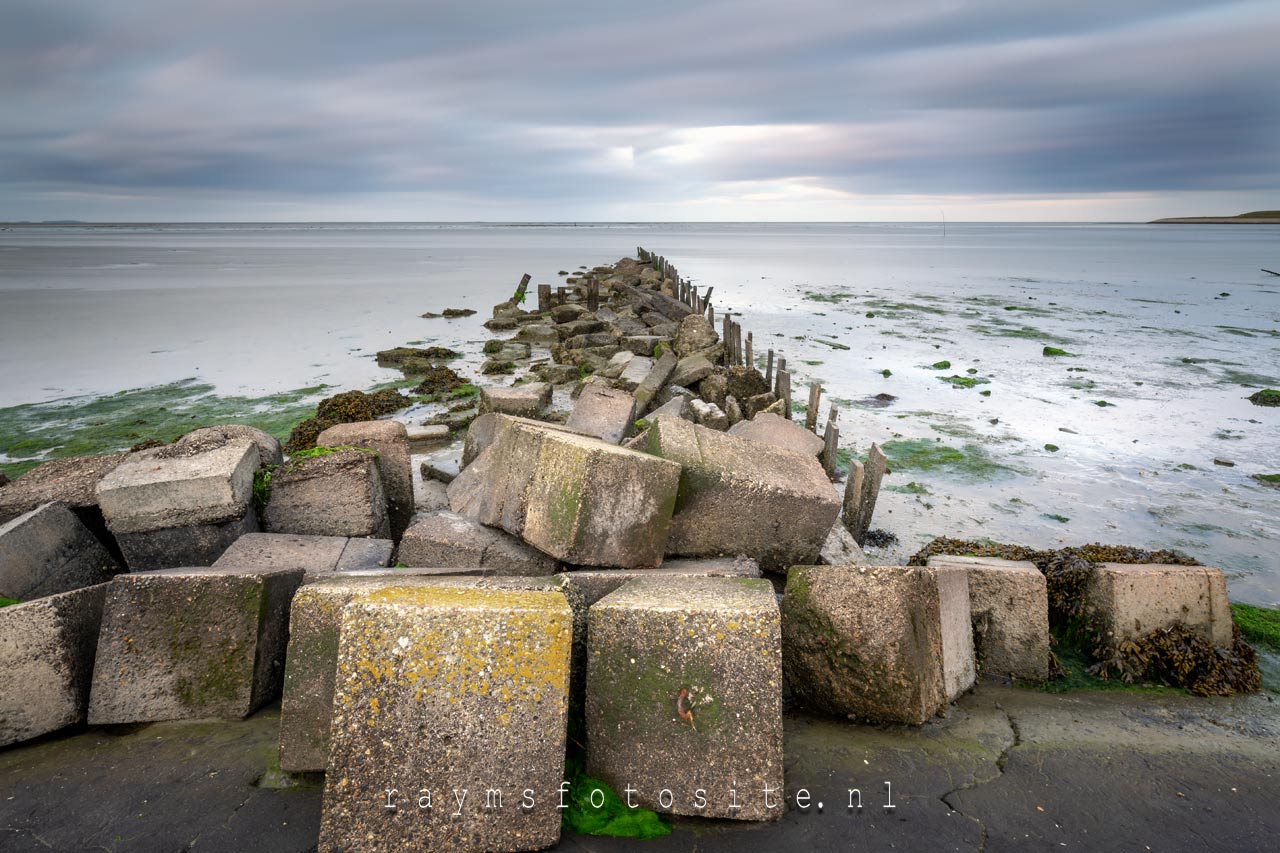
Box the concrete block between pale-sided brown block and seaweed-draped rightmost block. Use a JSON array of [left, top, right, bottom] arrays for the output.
[[929, 555, 1050, 683]]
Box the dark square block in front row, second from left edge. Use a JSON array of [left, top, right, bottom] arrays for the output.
[[88, 567, 302, 725]]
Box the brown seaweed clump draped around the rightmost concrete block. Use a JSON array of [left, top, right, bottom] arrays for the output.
[[909, 538, 1262, 695]]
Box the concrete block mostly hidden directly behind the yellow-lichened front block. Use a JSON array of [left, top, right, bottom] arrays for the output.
[[280, 569, 558, 772]]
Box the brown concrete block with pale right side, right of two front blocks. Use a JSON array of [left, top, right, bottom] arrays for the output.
[[782, 566, 973, 725]]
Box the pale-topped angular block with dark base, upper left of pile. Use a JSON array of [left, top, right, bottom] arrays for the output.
[[97, 434, 261, 571]]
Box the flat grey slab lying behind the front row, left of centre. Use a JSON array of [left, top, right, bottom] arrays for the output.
[[212, 533, 396, 580]]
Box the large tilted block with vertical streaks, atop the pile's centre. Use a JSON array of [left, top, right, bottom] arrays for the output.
[[449, 421, 680, 569]]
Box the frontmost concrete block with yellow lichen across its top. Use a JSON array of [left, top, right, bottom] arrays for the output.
[[320, 587, 572, 850]]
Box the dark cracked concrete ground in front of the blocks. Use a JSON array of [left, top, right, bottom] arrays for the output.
[[0, 683, 1280, 853]]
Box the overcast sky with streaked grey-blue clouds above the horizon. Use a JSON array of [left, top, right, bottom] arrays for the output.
[[0, 0, 1280, 222]]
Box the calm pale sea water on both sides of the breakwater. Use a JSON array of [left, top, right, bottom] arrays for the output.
[[0, 223, 1280, 606]]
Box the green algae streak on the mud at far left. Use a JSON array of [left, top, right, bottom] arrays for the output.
[[0, 379, 328, 476]]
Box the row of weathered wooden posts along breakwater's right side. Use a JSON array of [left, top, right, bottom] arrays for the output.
[[636, 246, 852, 479]]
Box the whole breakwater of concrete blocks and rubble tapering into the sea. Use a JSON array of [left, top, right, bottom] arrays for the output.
[[0, 250, 1231, 850]]
